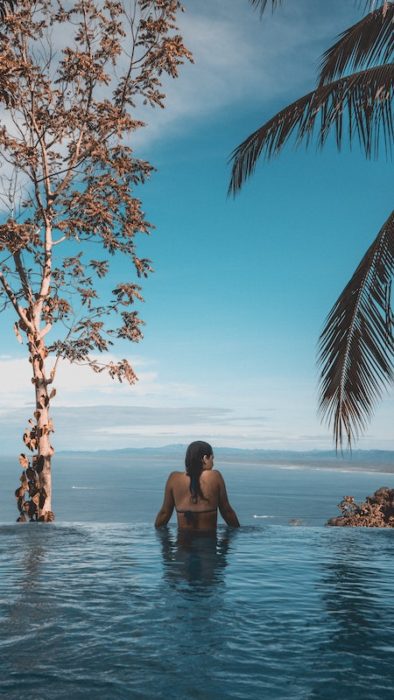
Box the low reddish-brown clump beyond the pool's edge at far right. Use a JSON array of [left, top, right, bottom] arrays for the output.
[[327, 486, 394, 527]]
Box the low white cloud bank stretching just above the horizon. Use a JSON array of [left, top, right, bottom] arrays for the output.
[[0, 356, 394, 453]]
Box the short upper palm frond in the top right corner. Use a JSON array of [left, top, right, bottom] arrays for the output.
[[319, 2, 394, 84]]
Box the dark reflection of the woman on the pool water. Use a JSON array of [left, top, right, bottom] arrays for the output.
[[157, 528, 236, 589]]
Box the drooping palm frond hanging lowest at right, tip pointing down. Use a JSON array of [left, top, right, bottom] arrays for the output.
[[318, 211, 394, 448]]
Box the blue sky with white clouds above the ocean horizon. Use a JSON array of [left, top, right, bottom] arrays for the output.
[[0, 0, 394, 453]]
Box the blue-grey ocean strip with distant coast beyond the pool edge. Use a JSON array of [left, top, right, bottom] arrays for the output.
[[0, 445, 394, 526]]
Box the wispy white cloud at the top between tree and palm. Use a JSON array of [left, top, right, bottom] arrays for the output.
[[133, 0, 358, 145]]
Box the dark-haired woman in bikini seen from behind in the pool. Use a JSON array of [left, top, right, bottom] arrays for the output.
[[155, 440, 239, 530]]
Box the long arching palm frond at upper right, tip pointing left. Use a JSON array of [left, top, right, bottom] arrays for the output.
[[229, 63, 394, 195]]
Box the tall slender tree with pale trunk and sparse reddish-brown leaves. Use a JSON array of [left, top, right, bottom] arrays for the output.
[[0, 0, 191, 521]]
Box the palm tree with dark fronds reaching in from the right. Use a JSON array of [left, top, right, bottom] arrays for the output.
[[230, 0, 394, 447]]
